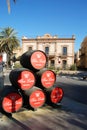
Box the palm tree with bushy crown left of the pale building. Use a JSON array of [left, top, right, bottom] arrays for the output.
[[0, 27, 20, 67]]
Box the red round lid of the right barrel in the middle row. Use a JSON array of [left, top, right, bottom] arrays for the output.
[[41, 70, 56, 88]]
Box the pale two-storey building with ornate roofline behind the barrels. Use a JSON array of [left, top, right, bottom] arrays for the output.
[[22, 34, 75, 69]]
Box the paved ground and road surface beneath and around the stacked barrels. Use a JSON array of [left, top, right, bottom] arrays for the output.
[[0, 73, 87, 130]]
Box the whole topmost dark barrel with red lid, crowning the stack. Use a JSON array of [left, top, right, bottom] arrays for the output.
[[20, 50, 47, 72]]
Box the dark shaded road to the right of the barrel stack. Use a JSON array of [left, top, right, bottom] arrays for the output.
[[56, 76, 87, 104]]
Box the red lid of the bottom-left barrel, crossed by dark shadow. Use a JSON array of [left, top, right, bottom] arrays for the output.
[[2, 92, 23, 113]]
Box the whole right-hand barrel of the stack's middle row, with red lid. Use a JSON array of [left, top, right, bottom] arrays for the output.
[[35, 68, 56, 89]]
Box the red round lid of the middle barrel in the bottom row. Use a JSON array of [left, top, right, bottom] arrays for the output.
[[29, 90, 45, 108]]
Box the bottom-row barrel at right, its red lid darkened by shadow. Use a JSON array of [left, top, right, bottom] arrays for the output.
[[45, 86, 64, 105]]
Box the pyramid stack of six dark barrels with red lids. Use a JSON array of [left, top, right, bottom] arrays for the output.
[[0, 50, 64, 113]]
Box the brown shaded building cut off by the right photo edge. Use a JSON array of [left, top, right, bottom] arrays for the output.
[[79, 37, 87, 69]]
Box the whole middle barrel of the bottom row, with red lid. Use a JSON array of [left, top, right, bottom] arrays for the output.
[[24, 86, 45, 109]]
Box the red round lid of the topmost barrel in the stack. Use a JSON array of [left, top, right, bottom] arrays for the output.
[[31, 50, 46, 70]]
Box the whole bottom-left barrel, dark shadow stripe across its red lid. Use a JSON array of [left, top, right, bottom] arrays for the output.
[[0, 85, 23, 113]]
